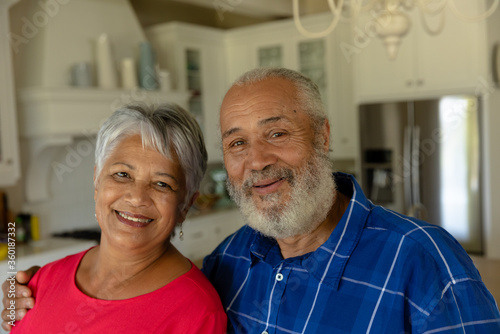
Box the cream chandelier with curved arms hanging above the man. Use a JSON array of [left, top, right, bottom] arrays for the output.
[[293, 0, 500, 59]]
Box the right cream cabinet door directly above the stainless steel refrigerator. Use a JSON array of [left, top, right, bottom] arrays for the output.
[[415, 0, 487, 90]]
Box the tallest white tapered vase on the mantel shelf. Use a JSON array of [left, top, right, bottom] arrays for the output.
[[96, 34, 118, 88]]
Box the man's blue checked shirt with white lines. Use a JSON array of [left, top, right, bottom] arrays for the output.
[[203, 173, 500, 334]]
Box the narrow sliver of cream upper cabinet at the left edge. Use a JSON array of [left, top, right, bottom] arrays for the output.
[[0, 0, 20, 187]]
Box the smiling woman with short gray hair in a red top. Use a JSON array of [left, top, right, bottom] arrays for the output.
[[12, 105, 226, 334]]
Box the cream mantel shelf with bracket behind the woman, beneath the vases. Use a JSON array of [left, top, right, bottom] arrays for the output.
[[18, 87, 190, 203]]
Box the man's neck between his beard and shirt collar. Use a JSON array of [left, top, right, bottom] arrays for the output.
[[277, 191, 350, 259]]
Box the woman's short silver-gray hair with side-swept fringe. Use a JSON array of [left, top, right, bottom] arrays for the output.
[[95, 104, 207, 205]]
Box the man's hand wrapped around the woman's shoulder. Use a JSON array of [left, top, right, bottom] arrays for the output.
[[2, 266, 40, 331]]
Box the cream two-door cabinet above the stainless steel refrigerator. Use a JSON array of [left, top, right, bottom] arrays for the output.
[[356, 0, 487, 102]]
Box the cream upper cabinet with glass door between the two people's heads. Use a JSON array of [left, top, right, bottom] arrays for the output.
[[145, 22, 227, 162]]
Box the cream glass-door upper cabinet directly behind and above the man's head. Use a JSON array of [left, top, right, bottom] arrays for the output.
[[226, 14, 357, 159]]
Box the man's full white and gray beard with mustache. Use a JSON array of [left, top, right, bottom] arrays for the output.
[[227, 151, 336, 239]]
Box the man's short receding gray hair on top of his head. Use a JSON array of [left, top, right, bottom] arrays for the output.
[[233, 67, 328, 132]]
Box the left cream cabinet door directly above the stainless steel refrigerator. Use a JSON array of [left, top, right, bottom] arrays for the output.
[[352, 14, 419, 101]]
